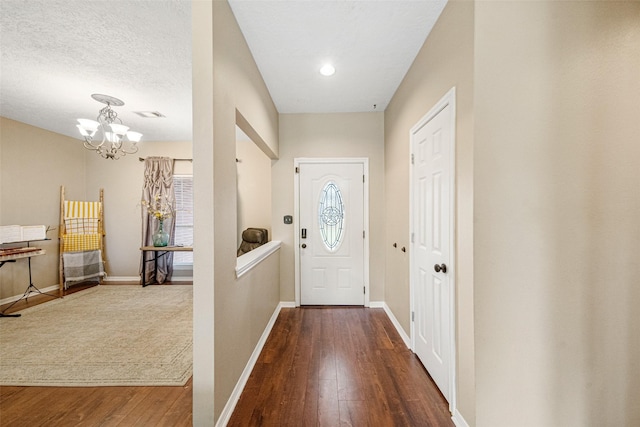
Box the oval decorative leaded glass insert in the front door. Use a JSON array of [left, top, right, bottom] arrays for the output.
[[318, 181, 345, 251]]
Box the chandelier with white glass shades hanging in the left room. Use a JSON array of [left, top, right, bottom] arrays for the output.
[[76, 93, 142, 160]]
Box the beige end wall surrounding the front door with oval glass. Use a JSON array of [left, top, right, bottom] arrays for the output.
[[272, 113, 385, 301]]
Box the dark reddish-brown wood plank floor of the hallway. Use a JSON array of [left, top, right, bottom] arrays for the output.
[[228, 307, 454, 427]]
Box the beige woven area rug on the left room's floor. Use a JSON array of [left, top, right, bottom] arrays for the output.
[[0, 285, 193, 386]]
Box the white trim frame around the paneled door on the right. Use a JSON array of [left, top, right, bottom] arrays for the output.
[[409, 86, 458, 414]]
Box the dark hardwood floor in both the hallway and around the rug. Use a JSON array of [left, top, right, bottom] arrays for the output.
[[0, 283, 453, 427]]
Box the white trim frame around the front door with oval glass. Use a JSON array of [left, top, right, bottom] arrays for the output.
[[293, 157, 370, 307]]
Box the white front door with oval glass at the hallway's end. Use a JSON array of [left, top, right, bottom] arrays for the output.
[[296, 162, 365, 305]]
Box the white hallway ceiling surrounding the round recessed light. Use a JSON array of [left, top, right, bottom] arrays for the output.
[[229, 0, 446, 113]]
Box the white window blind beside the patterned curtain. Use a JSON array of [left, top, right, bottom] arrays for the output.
[[173, 175, 193, 265]]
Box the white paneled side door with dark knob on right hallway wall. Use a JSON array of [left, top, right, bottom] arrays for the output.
[[411, 89, 454, 403]]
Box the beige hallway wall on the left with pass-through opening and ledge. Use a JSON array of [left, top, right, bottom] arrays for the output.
[[193, 1, 280, 425]]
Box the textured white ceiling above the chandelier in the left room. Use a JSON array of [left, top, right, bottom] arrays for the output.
[[0, 0, 191, 141]]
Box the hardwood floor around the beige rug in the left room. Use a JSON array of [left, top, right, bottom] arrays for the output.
[[0, 282, 193, 427]]
